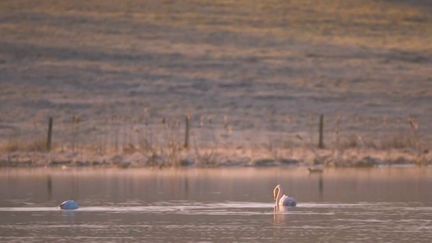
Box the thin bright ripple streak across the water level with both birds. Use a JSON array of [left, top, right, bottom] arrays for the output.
[[0, 202, 432, 215]]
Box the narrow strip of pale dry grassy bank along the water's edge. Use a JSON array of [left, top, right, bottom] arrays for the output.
[[0, 148, 432, 168]]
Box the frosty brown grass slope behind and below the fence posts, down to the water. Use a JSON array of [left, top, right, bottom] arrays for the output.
[[0, 0, 432, 164]]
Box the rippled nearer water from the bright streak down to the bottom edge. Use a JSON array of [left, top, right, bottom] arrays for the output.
[[0, 201, 432, 242]]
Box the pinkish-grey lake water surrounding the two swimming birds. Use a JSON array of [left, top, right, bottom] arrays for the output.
[[0, 168, 432, 242]]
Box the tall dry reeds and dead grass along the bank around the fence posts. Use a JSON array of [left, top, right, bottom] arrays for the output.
[[0, 113, 432, 167]]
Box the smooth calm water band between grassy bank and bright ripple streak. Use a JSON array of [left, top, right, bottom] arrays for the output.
[[0, 168, 432, 206]]
